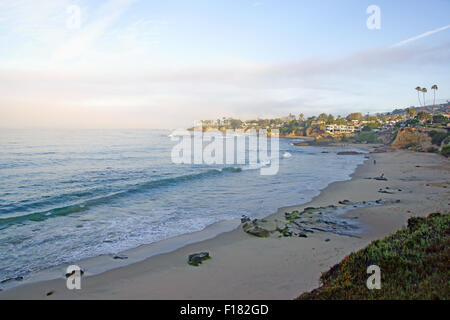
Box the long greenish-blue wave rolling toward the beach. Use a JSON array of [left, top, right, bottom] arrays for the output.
[[0, 167, 242, 230]]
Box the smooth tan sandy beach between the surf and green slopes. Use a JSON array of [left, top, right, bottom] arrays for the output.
[[0, 145, 450, 299]]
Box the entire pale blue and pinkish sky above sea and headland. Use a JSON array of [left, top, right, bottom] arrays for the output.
[[0, 0, 450, 129]]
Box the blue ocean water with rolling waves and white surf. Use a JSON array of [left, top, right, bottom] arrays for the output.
[[0, 129, 364, 287]]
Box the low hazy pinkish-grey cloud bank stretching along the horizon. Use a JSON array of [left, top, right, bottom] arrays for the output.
[[0, 39, 450, 128]]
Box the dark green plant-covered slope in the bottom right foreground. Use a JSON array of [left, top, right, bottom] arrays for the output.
[[298, 213, 450, 300]]
